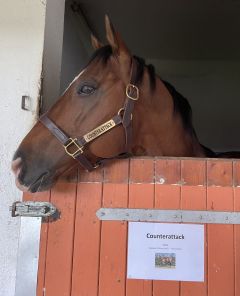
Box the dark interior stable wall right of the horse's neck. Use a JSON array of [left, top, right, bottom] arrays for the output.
[[149, 60, 240, 151]]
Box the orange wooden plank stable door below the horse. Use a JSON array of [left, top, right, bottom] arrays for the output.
[[25, 158, 240, 296]]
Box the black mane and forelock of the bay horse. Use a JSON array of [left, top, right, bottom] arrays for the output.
[[88, 45, 196, 136]]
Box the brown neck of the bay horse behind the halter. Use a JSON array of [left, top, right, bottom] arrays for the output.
[[132, 75, 205, 157]]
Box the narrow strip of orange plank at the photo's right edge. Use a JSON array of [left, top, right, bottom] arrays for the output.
[[233, 161, 240, 295]]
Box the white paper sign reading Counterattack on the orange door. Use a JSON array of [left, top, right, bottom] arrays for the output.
[[127, 222, 204, 282]]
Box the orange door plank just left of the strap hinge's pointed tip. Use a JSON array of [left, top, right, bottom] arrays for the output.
[[71, 169, 103, 296]]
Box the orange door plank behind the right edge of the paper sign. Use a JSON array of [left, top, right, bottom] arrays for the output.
[[180, 159, 207, 296]]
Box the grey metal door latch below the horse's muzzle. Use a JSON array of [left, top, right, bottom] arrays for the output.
[[10, 201, 58, 218]]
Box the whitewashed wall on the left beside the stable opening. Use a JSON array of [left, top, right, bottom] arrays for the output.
[[0, 0, 46, 296]]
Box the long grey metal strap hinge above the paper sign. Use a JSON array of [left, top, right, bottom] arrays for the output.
[[96, 208, 240, 224]]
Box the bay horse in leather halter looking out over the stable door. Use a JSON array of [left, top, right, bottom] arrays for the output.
[[12, 16, 234, 192]]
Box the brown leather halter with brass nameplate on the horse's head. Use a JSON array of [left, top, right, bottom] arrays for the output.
[[39, 59, 139, 171]]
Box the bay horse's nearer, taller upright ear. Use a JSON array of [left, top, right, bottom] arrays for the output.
[[105, 15, 130, 56]]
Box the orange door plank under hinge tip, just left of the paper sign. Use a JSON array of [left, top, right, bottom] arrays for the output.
[[98, 160, 128, 296]]
